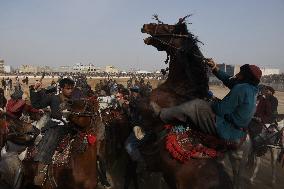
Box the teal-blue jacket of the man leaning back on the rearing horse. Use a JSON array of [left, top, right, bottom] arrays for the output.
[[212, 70, 258, 140]]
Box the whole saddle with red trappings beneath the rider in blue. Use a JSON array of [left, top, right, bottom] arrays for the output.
[[165, 125, 244, 163]]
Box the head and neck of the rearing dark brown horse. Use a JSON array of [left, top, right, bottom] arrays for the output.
[[141, 16, 209, 102]]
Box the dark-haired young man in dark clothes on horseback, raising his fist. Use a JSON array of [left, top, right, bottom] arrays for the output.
[[30, 78, 75, 185]]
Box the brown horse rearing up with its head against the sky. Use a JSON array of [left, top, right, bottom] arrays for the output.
[[140, 16, 232, 189]]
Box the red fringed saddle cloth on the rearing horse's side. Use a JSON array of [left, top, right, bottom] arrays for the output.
[[166, 125, 223, 163]]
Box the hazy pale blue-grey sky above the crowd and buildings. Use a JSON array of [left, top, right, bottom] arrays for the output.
[[0, 0, 284, 71]]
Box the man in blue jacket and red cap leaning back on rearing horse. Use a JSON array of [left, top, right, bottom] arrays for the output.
[[152, 59, 262, 144]]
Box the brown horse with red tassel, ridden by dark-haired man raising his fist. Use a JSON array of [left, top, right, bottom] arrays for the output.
[[22, 98, 99, 189]]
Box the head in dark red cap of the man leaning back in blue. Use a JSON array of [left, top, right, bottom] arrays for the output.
[[236, 64, 262, 85]]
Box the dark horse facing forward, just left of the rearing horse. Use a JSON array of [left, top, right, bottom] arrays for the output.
[[99, 107, 137, 188]]
